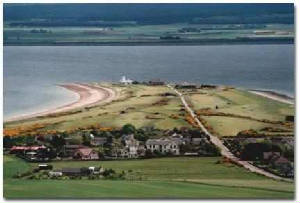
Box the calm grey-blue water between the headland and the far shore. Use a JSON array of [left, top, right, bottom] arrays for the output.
[[4, 45, 294, 119]]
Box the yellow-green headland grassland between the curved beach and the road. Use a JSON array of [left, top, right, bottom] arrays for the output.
[[5, 84, 189, 131]]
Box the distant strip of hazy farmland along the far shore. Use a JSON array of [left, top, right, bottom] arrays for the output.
[[4, 22, 294, 45]]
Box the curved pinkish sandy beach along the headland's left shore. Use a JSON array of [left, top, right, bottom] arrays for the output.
[[5, 83, 116, 122]]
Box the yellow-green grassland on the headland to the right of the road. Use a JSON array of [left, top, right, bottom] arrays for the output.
[[186, 89, 294, 136]]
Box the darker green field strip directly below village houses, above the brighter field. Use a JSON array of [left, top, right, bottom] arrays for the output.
[[32, 157, 272, 180]]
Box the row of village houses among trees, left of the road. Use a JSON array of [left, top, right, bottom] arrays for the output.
[[10, 133, 209, 162]]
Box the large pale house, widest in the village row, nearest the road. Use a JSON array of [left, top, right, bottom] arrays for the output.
[[146, 138, 180, 155]]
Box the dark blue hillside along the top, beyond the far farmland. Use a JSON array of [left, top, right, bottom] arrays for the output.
[[4, 4, 294, 26]]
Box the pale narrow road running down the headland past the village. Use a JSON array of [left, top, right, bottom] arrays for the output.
[[167, 84, 293, 182]]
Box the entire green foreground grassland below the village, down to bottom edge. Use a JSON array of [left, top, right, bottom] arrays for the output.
[[4, 156, 294, 199]]
